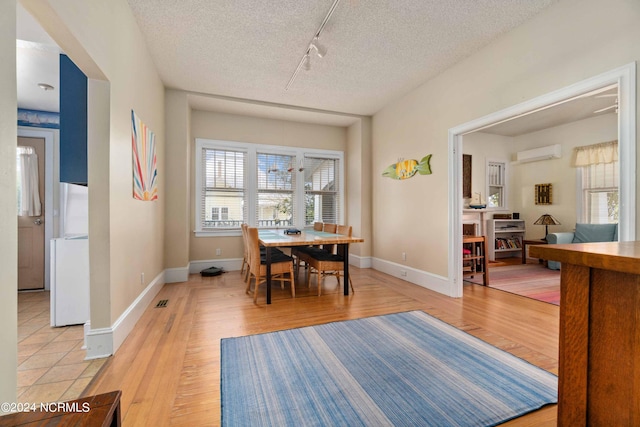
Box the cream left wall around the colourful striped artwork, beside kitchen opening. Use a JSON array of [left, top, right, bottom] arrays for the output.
[[22, 0, 165, 342]]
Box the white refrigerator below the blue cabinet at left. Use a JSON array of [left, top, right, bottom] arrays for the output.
[[51, 184, 90, 326]]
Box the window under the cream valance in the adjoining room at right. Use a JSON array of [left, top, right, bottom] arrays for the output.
[[582, 161, 619, 224]]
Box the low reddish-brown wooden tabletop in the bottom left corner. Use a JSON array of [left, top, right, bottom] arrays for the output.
[[0, 390, 122, 427]]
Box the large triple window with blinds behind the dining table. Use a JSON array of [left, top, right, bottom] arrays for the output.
[[195, 139, 344, 236]]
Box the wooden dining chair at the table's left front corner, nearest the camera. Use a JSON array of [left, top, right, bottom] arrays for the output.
[[245, 227, 296, 302]]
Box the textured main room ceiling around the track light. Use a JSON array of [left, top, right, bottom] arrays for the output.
[[129, 0, 557, 115]]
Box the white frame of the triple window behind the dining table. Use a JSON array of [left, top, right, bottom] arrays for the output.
[[194, 138, 346, 237]]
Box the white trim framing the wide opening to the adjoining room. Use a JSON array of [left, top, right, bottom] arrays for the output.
[[448, 62, 636, 297]]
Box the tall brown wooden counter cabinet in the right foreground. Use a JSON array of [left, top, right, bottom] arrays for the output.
[[529, 242, 640, 426]]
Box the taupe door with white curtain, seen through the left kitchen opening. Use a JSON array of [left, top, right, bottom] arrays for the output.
[[18, 137, 45, 290]]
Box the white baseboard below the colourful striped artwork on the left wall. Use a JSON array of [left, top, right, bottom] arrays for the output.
[[85, 271, 165, 360]]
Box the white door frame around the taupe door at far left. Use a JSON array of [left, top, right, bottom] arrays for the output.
[[18, 126, 56, 291]]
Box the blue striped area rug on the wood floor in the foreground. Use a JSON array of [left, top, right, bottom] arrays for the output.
[[220, 311, 558, 427]]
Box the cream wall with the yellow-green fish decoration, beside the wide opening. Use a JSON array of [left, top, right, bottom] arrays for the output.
[[372, 0, 640, 284]]
